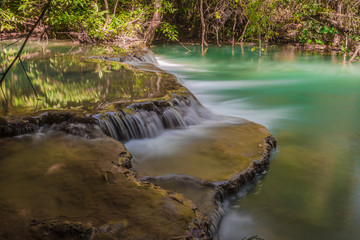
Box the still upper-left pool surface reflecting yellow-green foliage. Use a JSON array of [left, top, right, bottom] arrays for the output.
[[0, 42, 170, 114]]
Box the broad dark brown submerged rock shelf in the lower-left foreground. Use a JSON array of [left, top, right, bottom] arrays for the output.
[[0, 132, 206, 240]]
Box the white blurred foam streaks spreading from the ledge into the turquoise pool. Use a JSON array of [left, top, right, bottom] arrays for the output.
[[157, 56, 296, 129]]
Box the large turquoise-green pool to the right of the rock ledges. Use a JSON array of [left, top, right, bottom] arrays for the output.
[[154, 45, 360, 240]]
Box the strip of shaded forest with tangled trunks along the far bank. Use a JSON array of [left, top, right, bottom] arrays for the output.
[[0, 0, 360, 52]]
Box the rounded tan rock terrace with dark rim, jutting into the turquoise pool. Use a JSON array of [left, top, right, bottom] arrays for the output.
[[129, 121, 276, 235]]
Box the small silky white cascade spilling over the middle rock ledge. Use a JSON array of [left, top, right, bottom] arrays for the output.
[[94, 97, 209, 141]]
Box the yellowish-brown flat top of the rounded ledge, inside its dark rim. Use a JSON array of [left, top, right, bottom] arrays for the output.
[[135, 122, 271, 182]]
